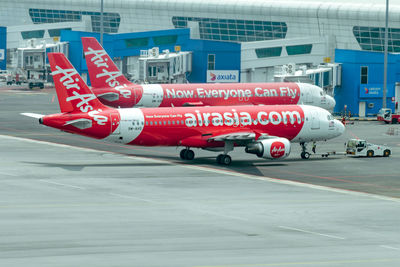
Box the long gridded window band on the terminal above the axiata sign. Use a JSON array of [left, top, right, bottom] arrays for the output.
[[172, 16, 287, 42]]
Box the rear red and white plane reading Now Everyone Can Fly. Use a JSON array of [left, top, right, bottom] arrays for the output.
[[82, 37, 336, 110]]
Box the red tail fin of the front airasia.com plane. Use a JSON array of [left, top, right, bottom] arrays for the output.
[[48, 53, 106, 113]]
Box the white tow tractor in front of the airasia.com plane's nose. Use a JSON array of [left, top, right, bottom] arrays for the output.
[[346, 139, 392, 157]]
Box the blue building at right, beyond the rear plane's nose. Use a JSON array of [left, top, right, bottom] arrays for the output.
[[335, 49, 400, 117]]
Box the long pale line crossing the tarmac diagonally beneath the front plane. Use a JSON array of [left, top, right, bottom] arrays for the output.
[[0, 135, 400, 203]]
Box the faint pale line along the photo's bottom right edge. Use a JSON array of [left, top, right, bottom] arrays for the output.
[[193, 258, 400, 267]]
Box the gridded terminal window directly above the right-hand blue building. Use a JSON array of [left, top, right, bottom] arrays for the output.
[[353, 26, 400, 53]]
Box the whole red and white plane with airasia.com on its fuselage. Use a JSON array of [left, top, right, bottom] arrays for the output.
[[23, 53, 344, 165]]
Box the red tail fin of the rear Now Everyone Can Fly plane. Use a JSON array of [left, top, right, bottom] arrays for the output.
[[82, 37, 133, 88]]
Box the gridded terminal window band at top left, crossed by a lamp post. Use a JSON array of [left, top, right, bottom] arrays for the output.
[[29, 8, 121, 33]]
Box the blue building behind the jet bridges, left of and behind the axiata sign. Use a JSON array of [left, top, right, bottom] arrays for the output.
[[61, 29, 241, 83]]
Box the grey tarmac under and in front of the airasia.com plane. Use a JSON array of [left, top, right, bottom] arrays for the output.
[[0, 85, 400, 267]]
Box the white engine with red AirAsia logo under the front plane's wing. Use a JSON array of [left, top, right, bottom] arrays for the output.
[[245, 138, 291, 159]]
